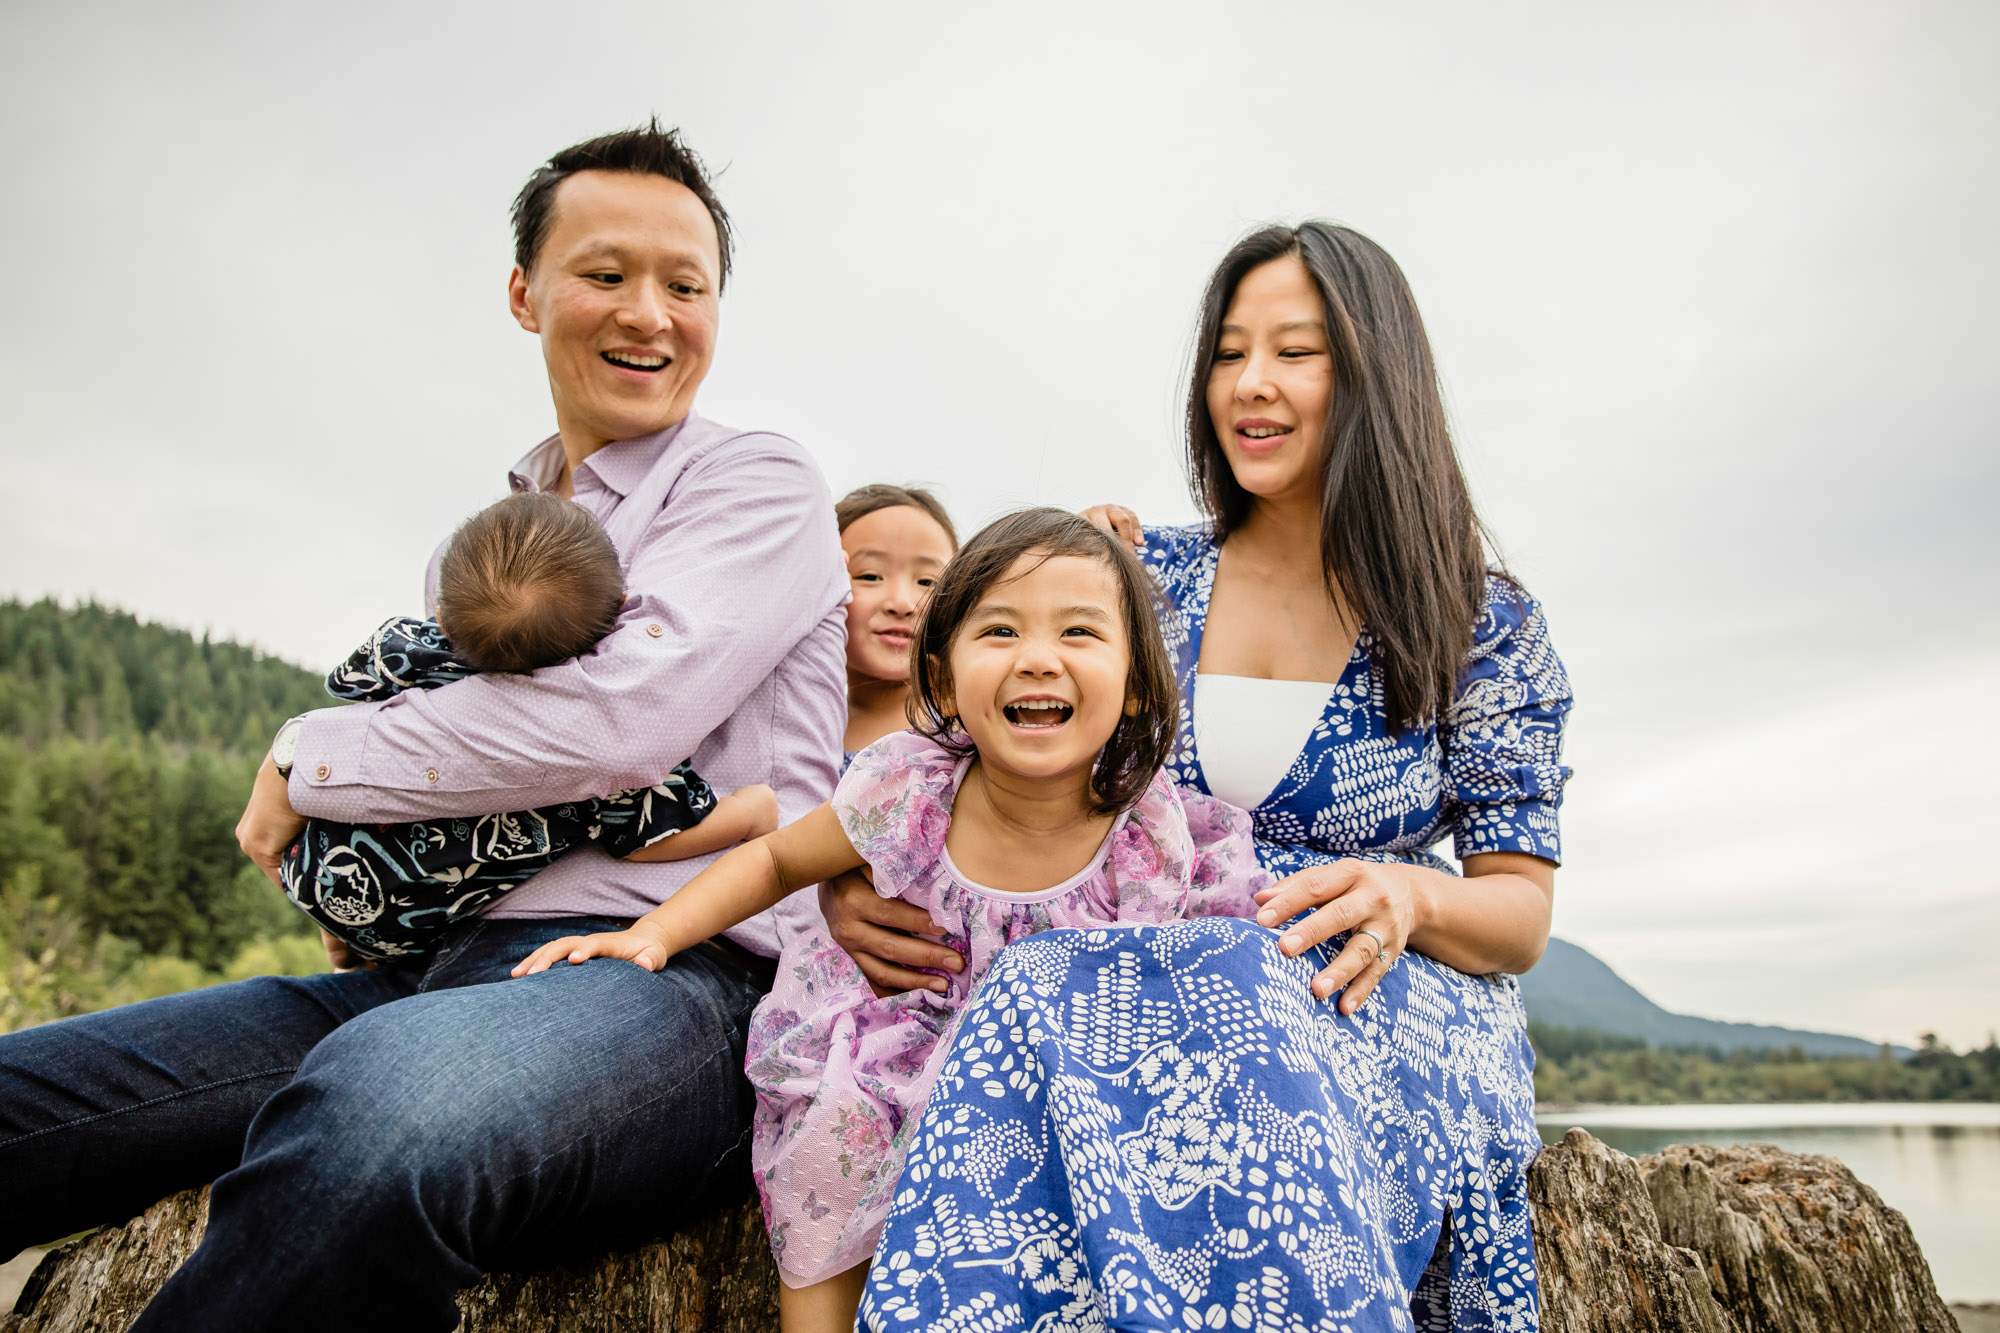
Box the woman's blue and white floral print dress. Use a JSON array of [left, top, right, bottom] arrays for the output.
[[860, 526, 1570, 1333]]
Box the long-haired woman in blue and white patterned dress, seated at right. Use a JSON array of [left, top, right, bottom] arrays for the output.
[[826, 222, 1570, 1329]]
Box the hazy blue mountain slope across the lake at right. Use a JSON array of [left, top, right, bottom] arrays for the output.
[[1520, 939, 1910, 1057]]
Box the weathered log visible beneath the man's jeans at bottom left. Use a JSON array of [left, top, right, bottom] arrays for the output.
[[0, 1189, 778, 1333]]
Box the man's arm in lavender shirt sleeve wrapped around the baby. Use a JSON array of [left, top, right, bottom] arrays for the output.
[[288, 434, 838, 823]]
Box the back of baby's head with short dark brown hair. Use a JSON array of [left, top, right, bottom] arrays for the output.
[[438, 490, 624, 671]]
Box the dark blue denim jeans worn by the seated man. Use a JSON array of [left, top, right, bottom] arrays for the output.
[[0, 919, 768, 1329]]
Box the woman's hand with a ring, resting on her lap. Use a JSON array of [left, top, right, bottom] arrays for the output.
[[1256, 861, 1428, 1013]]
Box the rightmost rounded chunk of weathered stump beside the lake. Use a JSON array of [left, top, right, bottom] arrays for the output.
[[1640, 1143, 1958, 1333]]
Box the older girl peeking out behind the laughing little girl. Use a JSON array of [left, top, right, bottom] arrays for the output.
[[834, 484, 958, 759]]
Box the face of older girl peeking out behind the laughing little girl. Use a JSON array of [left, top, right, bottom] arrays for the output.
[[840, 504, 952, 681]]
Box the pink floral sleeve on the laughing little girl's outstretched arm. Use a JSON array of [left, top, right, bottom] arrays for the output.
[[832, 731, 958, 899]]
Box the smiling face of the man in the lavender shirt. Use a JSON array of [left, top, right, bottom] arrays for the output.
[[508, 172, 722, 456]]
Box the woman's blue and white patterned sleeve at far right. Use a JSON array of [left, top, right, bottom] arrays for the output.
[[1438, 574, 1570, 863]]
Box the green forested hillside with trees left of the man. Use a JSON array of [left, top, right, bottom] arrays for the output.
[[0, 600, 328, 1031]]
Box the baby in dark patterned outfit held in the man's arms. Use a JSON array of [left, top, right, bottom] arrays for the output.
[[278, 494, 778, 961]]
